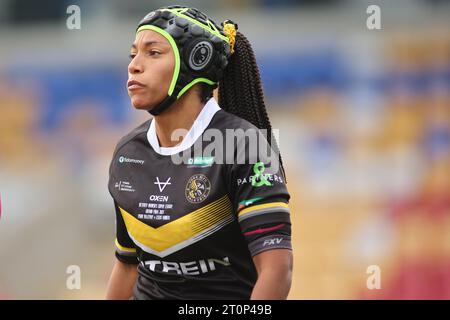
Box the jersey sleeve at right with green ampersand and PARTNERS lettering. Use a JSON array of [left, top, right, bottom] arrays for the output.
[[226, 129, 292, 256]]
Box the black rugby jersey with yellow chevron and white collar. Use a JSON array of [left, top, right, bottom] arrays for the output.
[[108, 98, 291, 299]]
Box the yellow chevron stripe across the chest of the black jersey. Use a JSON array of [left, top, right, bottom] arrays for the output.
[[119, 195, 234, 257]]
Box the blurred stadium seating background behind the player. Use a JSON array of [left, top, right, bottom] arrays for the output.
[[0, 0, 450, 299]]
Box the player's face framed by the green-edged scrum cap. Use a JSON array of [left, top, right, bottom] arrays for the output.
[[127, 30, 175, 110]]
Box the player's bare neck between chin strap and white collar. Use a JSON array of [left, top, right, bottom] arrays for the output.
[[154, 90, 205, 148]]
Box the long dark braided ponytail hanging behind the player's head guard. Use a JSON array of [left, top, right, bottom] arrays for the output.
[[219, 31, 286, 181]]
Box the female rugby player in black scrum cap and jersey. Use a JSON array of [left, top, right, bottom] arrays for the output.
[[106, 6, 293, 299]]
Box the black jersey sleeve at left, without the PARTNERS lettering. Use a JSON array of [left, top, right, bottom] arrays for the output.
[[114, 201, 138, 264]]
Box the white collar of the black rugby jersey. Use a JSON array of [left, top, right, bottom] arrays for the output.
[[147, 97, 220, 156]]
